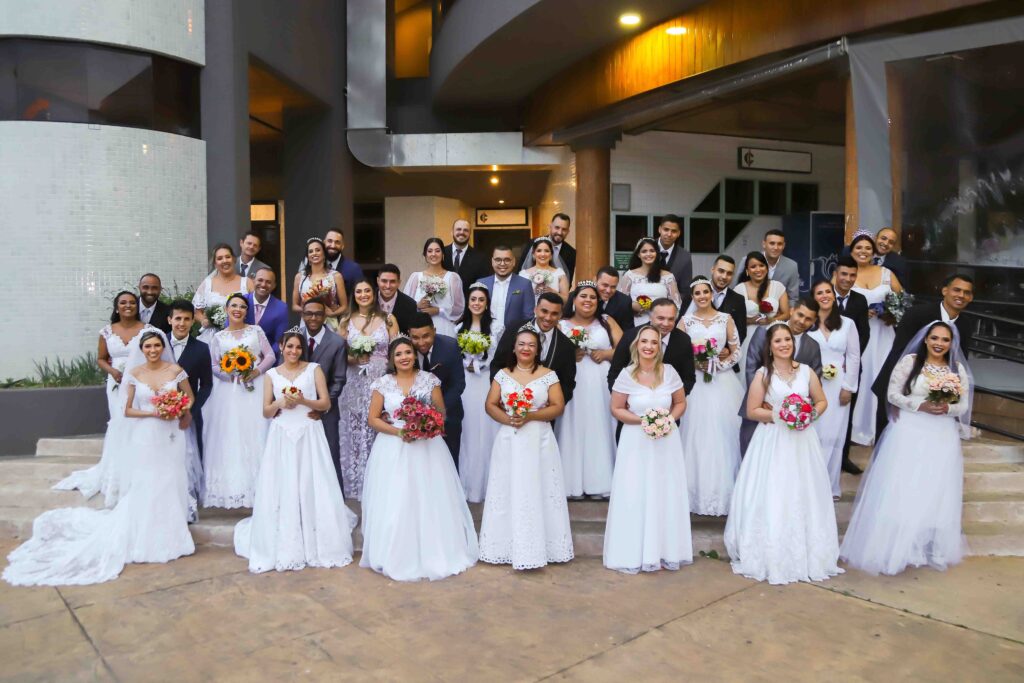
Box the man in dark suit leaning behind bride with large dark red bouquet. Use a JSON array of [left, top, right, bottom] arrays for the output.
[[409, 312, 466, 469]]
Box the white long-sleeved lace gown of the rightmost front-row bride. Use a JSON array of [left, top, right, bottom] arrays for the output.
[[840, 353, 969, 574]]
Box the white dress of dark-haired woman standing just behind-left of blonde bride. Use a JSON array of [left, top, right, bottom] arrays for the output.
[[555, 321, 615, 497]]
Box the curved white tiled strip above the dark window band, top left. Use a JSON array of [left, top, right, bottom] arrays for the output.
[[0, 0, 205, 65]]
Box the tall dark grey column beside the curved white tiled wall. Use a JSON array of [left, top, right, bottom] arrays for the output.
[[200, 0, 250, 251]]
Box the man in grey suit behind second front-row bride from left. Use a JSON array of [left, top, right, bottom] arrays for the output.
[[302, 299, 348, 486]]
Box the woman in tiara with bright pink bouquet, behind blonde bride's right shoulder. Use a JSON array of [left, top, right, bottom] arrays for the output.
[[677, 275, 743, 516]]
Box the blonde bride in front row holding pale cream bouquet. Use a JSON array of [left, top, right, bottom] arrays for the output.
[[604, 325, 693, 573]]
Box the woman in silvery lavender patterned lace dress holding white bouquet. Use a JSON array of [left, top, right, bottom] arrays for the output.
[[338, 278, 398, 501]]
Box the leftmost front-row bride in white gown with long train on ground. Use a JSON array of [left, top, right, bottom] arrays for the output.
[[3, 330, 196, 586]]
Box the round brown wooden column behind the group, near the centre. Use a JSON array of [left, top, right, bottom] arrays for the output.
[[572, 143, 613, 281]]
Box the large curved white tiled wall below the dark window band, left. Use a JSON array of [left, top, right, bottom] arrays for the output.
[[0, 121, 208, 378]]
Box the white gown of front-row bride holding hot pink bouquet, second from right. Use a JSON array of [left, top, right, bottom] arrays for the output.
[[725, 365, 843, 584]]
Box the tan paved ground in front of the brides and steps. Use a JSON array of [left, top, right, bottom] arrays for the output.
[[0, 544, 1024, 682]]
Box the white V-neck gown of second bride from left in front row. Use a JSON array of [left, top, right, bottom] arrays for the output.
[[234, 362, 356, 573]]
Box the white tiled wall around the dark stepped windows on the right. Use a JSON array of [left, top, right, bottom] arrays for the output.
[[611, 131, 846, 273]]
